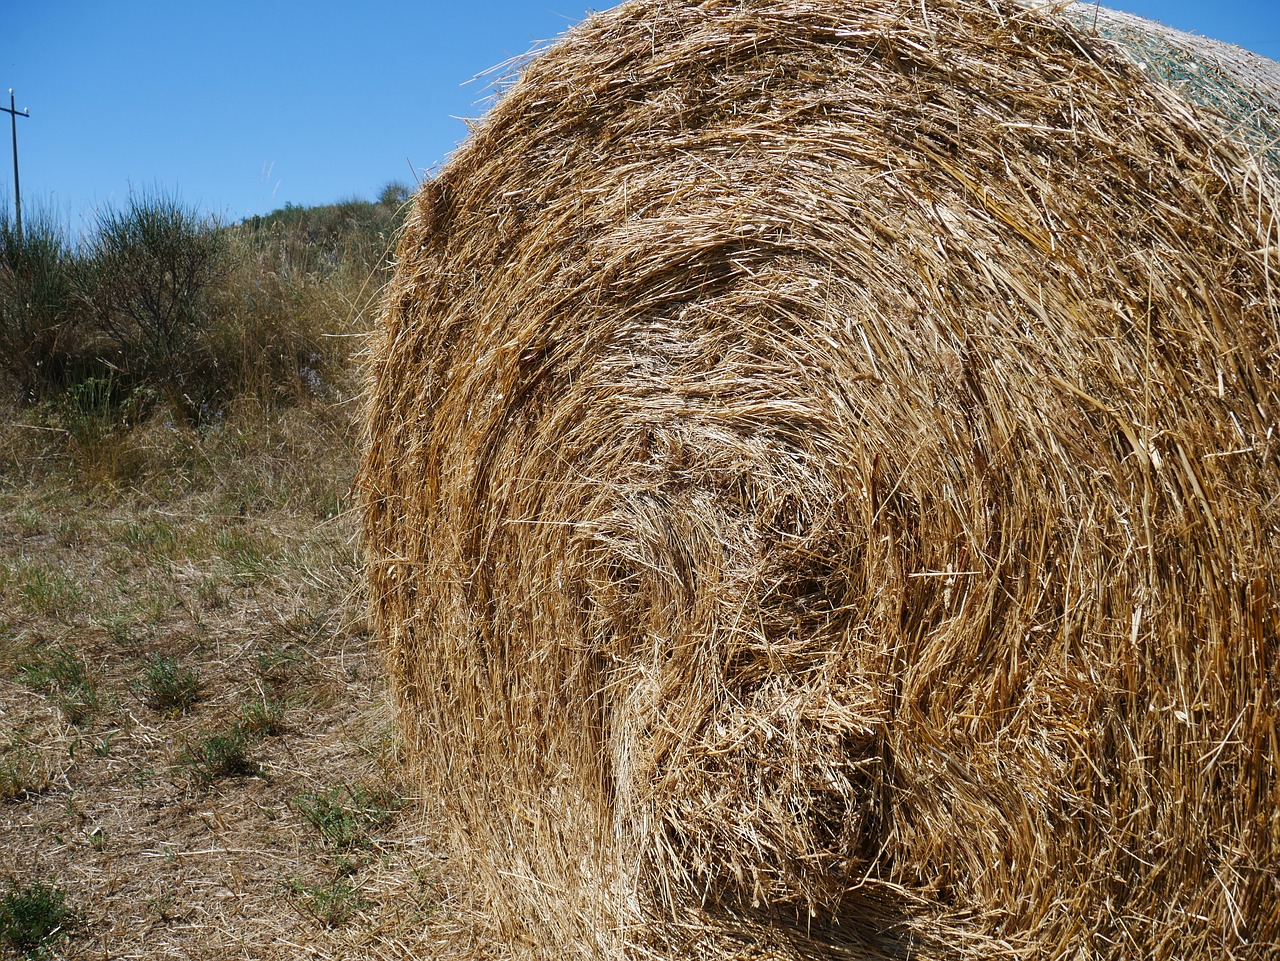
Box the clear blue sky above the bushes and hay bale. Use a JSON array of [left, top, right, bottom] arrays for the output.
[[0, 0, 1280, 225]]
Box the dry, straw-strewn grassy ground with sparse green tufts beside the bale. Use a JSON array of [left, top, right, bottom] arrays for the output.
[[0, 402, 471, 958]]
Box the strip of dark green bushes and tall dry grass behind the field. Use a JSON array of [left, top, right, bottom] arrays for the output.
[[0, 183, 410, 445]]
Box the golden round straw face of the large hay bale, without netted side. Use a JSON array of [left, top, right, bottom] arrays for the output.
[[361, 0, 1280, 958]]
